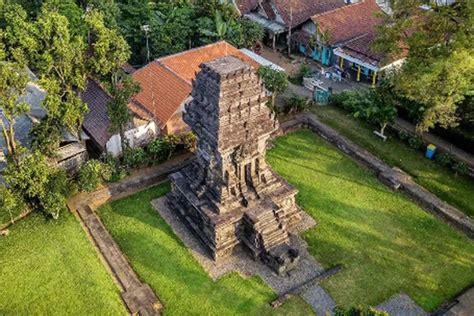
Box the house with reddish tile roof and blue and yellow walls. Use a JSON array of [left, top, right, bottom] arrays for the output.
[[292, 0, 403, 83]]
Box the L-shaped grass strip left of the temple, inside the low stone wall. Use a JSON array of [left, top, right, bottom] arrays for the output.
[[98, 184, 312, 315]]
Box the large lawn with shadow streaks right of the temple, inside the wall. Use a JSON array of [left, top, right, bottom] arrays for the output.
[[267, 130, 474, 311]]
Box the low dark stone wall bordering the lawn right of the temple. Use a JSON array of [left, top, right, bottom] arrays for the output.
[[275, 113, 474, 239]]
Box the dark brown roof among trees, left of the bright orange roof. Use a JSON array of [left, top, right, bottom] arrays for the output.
[[81, 80, 112, 149]]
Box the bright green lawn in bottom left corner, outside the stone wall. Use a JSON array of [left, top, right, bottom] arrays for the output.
[[0, 213, 127, 315]]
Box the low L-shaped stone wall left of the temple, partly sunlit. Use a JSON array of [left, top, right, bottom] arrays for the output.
[[68, 154, 192, 316]]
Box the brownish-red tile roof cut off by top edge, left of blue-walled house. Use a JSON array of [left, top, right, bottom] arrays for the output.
[[273, 0, 346, 27]]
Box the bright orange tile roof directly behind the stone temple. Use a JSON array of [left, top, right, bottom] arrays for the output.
[[129, 42, 259, 126]]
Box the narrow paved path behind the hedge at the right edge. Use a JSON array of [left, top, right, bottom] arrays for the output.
[[395, 118, 474, 169]]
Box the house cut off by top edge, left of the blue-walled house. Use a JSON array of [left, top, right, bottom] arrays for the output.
[[239, 0, 350, 49]]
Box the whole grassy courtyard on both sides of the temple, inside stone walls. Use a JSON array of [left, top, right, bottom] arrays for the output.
[[90, 130, 474, 315]]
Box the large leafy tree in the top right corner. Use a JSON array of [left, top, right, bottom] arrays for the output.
[[374, 0, 474, 131]]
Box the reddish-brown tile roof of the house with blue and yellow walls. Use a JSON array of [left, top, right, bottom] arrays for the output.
[[313, 0, 383, 45]]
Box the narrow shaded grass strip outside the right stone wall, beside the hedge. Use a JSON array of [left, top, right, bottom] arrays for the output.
[[313, 106, 474, 217]]
